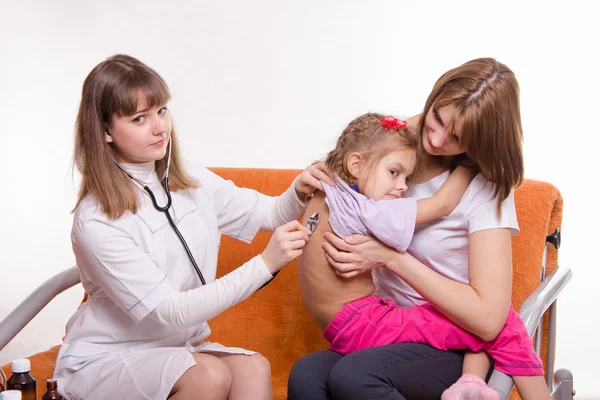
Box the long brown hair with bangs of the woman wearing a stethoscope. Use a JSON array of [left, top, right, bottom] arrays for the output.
[[74, 54, 198, 219]]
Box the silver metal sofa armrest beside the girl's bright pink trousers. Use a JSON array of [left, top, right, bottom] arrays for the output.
[[488, 265, 573, 400]]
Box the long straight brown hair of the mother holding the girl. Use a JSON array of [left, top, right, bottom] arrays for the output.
[[419, 58, 525, 211]]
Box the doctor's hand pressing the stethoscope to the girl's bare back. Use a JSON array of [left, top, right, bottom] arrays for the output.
[[260, 220, 312, 274]]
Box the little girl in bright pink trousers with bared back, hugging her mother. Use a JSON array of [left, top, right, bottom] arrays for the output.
[[298, 114, 548, 400]]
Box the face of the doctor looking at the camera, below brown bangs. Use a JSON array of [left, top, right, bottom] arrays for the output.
[[106, 97, 171, 163]]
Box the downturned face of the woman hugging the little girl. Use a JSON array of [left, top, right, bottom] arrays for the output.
[[423, 105, 465, 156]]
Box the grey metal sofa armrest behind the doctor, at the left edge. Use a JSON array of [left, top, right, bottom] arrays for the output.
[[0, 266, 80, 350]]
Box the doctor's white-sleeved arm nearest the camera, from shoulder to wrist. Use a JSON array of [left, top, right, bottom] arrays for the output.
[[72, 216, 273, 327]]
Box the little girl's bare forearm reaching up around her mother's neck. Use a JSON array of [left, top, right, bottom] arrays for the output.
[[416, 165, 476, 224]]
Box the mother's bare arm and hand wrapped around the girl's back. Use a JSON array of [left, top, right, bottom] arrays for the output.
[[323, 228, 512, 341]]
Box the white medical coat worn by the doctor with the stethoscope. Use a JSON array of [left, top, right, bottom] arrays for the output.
[[55, 163, 274, 398]]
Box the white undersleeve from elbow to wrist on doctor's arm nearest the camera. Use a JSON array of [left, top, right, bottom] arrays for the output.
[[149, 255, 272, 329]]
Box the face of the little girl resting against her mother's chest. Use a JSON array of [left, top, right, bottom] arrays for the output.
[[356, 146, 417, 201]]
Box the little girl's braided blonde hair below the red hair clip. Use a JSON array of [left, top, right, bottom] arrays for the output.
[[325, 113, 420, 185]]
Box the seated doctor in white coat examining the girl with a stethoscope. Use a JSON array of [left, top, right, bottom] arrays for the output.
[[54, 55, 331, 400]]
